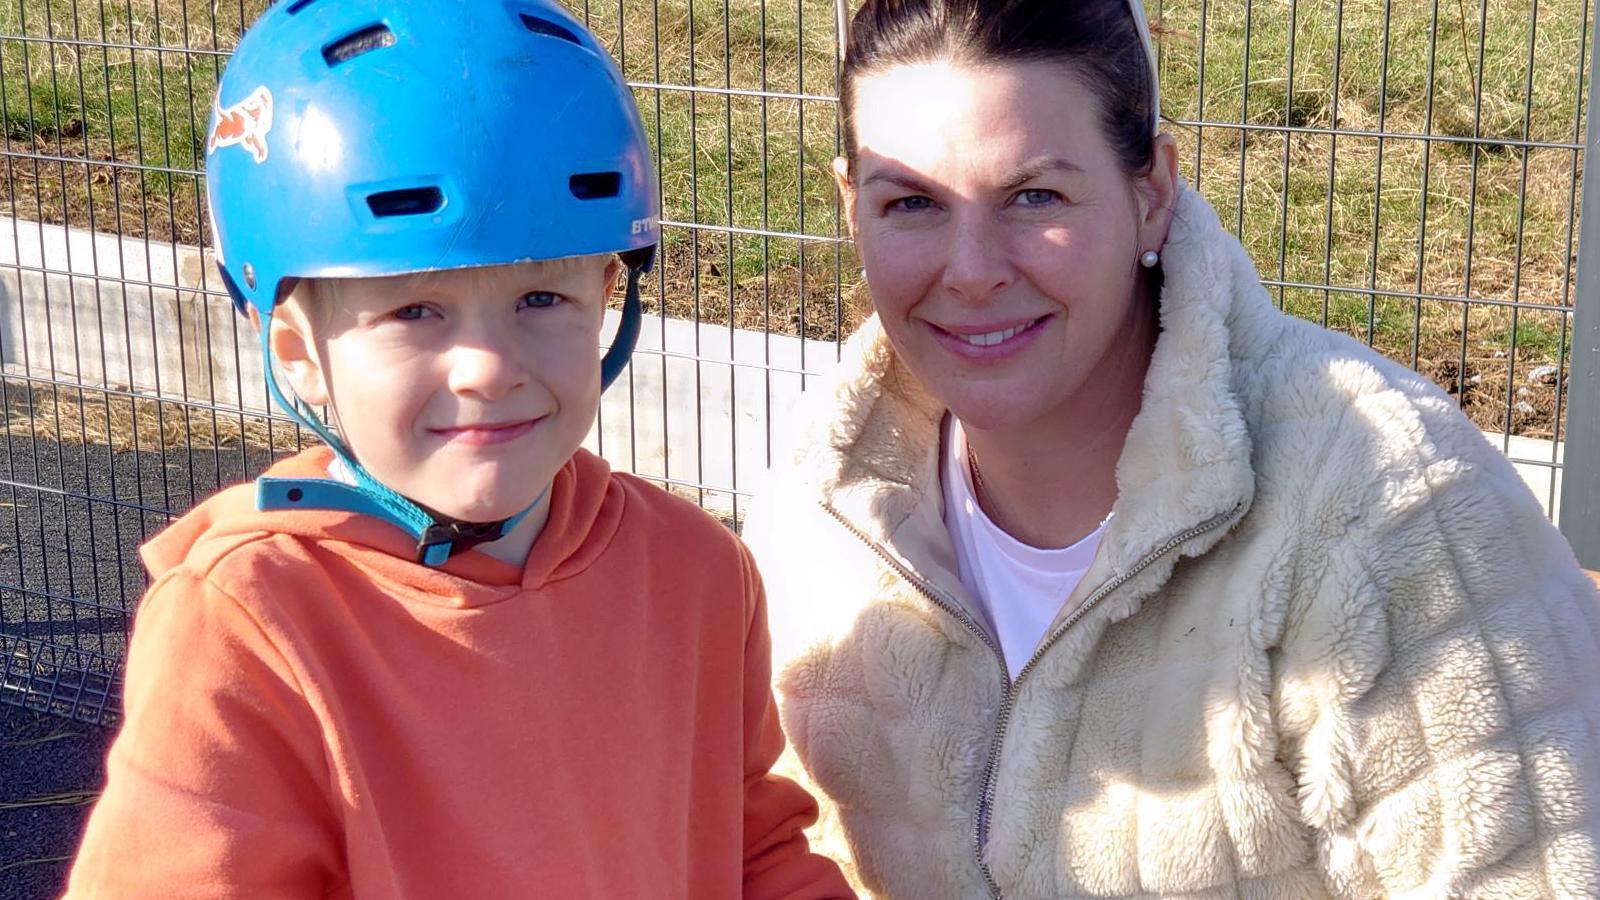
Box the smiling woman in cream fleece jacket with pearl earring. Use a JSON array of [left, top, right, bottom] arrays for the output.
[[747, 0, 1600, 898]]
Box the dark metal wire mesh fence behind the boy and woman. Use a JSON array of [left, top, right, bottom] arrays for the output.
[[0, 0, 1592, 724]]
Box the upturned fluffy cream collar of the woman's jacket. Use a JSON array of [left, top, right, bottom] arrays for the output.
[[798, 187, 1270, 586]]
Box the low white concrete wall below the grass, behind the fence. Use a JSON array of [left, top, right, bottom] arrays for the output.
[[0, 218, 1563, 512]]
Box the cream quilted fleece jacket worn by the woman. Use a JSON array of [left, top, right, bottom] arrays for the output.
[[746, 189, 1600, 900]]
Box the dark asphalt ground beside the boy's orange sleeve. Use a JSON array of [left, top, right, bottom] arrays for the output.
[[0, 429, 284, 900]]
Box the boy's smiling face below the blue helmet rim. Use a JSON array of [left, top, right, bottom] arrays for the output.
[[272, 256, 621, 522]]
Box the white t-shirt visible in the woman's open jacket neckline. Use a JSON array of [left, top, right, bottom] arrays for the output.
[[944, 416, 1106, 677]]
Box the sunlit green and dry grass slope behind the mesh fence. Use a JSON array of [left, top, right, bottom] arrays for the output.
[[0, 0, 1590, 434]]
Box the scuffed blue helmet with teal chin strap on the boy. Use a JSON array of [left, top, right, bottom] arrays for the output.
[[205, 0, 661, 564]]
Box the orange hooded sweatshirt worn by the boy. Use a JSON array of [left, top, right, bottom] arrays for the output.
[[67, 448, 851, 900]]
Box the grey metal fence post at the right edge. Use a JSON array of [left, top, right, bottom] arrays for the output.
[[1560, 22, 1600, 570]]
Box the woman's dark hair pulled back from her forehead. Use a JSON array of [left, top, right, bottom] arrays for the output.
[[840, 0, 1155, 175]]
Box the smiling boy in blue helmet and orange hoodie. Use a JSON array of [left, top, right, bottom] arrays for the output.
[[67, 0, 848, 898]]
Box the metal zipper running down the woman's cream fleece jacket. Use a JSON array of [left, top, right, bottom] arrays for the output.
[[821, 501, 1245, 900]]
